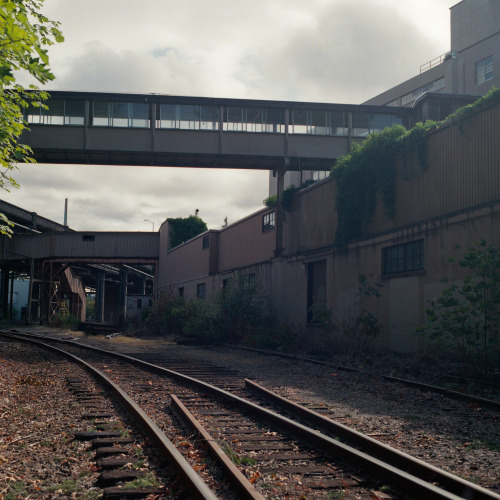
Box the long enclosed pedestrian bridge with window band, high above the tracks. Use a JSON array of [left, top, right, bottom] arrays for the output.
[[22, 91, 412, 170]]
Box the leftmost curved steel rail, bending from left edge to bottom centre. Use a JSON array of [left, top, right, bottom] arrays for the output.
[[0, 332, 217, 500]]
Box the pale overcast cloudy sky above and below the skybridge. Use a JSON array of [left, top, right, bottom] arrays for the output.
[[1, 0, 458, 231]]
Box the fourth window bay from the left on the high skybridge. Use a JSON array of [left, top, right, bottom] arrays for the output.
[[223, 106, 285, 134]]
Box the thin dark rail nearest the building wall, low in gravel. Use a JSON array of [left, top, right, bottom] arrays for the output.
[[222, 344, 500, 410]]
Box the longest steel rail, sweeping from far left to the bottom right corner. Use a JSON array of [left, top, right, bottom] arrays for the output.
[[5, 334, 494, 500]]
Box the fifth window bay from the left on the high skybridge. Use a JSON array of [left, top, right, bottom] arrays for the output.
[[288, 109, 347, 136]]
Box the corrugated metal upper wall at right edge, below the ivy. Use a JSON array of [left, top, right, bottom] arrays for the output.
[[367, 105, 500, 234]]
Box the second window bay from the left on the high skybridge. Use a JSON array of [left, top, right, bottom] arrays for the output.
[[92, 101, 150, 128]]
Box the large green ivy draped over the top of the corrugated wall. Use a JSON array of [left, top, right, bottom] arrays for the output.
[[330, 89, 500, 246]]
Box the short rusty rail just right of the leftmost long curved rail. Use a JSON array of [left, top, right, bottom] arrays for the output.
[[170, 394, 264, 500]]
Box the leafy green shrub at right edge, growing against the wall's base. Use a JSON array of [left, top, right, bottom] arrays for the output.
[[418, 240, 500, 376]]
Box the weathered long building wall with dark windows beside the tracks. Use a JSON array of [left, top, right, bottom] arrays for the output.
[[157, 96, 500, 352]]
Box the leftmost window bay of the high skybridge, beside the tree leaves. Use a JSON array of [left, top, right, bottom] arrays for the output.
[[25, 99, 85, 125]]
